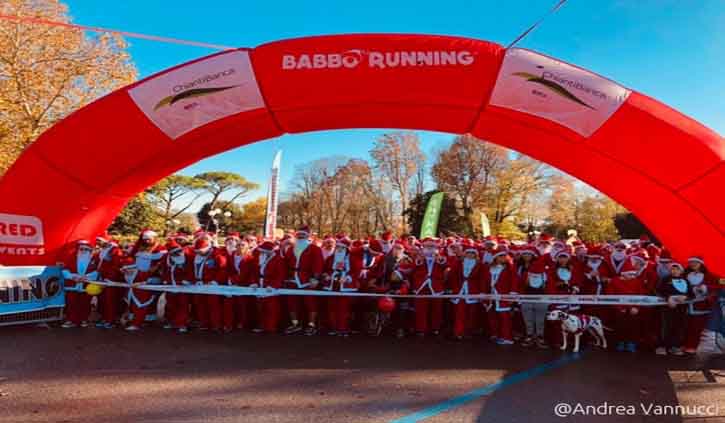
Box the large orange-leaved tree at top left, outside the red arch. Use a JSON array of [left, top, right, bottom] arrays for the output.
[[0, 0, 137, 175]]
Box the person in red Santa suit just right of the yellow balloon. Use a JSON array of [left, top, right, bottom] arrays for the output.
[[96, 233, 123, 329]]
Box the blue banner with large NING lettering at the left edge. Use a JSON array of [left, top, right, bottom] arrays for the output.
[[0, 266, 65, 326]]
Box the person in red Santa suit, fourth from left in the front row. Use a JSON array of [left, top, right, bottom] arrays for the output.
[[161, 240, 194, 333]]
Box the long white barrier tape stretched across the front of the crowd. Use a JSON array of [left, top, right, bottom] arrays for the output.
[[66, 281, 680, 306]]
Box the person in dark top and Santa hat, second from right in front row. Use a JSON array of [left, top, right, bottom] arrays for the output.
[[655, 262, 692, 356]]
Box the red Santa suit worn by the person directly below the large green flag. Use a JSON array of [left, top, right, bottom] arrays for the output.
[[412, 256, 448, 333]]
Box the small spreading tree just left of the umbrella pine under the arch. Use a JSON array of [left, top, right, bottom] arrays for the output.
[[146, 175, 206, 235]]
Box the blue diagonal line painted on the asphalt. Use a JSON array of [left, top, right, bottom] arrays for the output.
[[390, 353, 581, 423]]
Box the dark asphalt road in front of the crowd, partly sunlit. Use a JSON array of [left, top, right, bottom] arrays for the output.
[[0, 327, 725, 423]]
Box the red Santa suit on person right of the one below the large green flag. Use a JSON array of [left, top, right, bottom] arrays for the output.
[[448, 258, 483, 337]]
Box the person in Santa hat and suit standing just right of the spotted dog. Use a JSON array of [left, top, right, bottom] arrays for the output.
[[604, 259, 647, 352]]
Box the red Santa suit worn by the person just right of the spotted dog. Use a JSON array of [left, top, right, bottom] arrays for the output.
[[604, 274, 647, 342]]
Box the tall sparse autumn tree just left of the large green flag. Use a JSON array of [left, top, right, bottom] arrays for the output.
[[370, 132, 425, 227]]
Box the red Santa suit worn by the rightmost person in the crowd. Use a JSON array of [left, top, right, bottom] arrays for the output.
[[684, 269, 717, 350]]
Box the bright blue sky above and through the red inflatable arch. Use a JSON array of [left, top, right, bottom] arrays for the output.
[[64, 0, 725, 211]]
